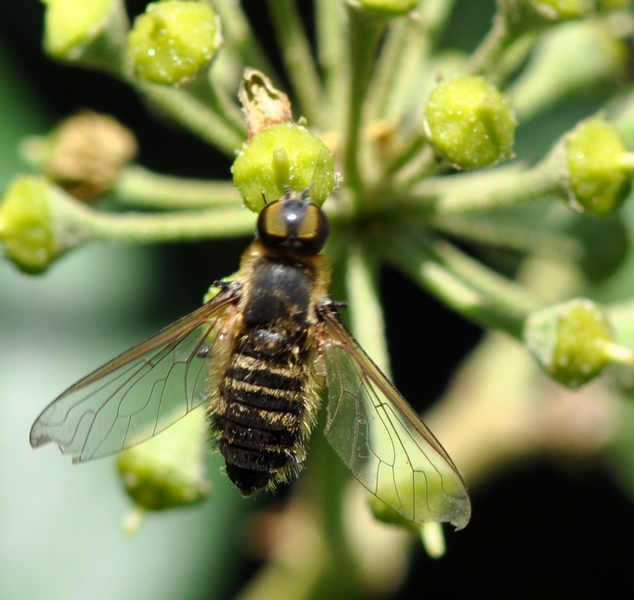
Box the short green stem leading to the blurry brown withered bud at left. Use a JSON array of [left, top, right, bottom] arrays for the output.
[[113, 165, 242, 210]]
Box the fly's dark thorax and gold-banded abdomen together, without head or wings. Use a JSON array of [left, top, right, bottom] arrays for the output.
[[211, 261, 317, 495]]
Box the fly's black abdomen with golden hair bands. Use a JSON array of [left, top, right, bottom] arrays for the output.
[[214, 329, 312, 495]]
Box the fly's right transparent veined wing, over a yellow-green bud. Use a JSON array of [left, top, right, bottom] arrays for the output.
[[323, 311, 471, 529]]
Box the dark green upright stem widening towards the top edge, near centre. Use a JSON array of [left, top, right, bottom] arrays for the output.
[[344, 4, 388, 205]]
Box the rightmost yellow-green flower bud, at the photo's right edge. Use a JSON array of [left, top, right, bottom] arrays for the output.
[[565, 117, 634, 216]]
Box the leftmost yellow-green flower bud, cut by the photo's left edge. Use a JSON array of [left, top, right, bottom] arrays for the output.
[[0, 176, 60, 274]]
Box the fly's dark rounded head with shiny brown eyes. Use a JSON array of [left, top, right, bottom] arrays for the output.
[[258, 195, 329, 256]]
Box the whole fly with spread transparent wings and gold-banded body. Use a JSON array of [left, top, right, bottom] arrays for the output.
[[30, 190, 471, 528]]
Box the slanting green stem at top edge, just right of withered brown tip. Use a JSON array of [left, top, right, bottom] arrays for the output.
[[268, 0, 326, 127]]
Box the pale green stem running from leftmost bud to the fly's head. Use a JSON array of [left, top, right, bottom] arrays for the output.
[[53, 191, 255, 248]]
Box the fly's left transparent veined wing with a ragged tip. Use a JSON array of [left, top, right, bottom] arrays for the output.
[[30, 290, 236, 462]]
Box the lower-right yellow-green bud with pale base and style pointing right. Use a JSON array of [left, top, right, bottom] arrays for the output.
[[524, 298, 616, 389]]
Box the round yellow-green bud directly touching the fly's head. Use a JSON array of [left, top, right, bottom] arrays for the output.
[[231, 123, 336, 212]]
